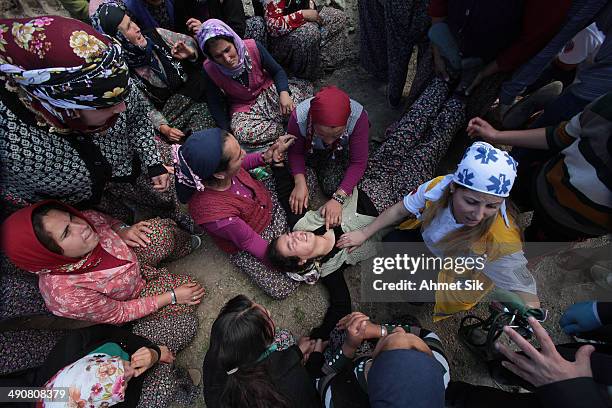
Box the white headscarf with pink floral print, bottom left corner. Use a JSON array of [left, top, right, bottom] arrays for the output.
[[41, 353, 127, 408]]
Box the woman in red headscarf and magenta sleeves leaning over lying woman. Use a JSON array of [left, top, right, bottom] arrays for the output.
[[287, 86, 370, 230]]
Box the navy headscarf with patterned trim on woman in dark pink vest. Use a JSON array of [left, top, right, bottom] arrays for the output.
[[172, 128, 225, 203]]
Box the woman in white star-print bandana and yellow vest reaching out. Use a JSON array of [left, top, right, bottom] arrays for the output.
[[336, 142, 539, 321]]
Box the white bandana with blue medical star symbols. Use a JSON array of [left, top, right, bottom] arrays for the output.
[[453, 142, 518, 225]]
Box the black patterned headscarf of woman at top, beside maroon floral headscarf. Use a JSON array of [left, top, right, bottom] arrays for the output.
[[91, 0, 186, 89]]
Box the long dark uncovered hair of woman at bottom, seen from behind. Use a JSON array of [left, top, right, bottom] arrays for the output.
[[208, 295, 289, 408]]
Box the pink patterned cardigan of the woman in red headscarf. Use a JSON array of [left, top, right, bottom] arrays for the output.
[[38, 211, 157, 324]]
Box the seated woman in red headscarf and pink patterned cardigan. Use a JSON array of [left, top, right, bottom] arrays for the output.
[[2, 200, 204, 351]]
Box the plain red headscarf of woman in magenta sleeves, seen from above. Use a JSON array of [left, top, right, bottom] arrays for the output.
[[309, 86, 351, 127]]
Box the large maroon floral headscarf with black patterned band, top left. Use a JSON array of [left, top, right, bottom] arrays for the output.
[[0, 16, 129, 123]]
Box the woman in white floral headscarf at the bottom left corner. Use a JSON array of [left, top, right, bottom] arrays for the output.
[[2, 325, 198, 408]]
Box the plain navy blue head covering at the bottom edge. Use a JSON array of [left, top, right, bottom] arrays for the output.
[[368, 349, 445, 408]]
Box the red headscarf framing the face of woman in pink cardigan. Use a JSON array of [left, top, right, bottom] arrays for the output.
[[1, 200, 127, 274]]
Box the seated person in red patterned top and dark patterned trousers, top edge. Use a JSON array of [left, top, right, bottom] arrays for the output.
[[253, 0, 350, 80]]
